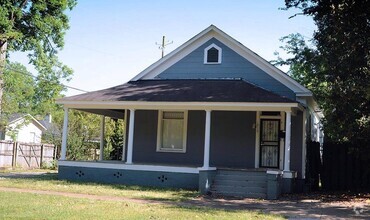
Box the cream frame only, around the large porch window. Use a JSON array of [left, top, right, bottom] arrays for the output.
[[157, 110, 188, 153]]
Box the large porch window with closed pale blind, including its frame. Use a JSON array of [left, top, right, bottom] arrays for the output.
[[157, 111, 187, 153]]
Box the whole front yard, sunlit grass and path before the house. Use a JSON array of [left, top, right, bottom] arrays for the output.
[[0, 171, 370, 219]]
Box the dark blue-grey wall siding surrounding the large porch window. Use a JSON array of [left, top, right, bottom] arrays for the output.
[[133, 110, 205, 166]]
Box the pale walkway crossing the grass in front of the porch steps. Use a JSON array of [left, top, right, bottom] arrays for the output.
[[0, 173, 370, 219]]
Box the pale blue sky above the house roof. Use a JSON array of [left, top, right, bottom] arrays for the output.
[[10, 0, 315, 96]]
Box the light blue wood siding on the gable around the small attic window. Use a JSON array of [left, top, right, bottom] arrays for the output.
[[157, 38, 295, 99]]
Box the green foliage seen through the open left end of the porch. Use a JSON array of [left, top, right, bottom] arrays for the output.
[[49, 110, 124, 160]]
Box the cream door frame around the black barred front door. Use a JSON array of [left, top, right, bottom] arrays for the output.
[[254, 111, 285, 170]]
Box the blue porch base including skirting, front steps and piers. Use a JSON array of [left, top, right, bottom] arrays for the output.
[[58, 161, 291, 199]]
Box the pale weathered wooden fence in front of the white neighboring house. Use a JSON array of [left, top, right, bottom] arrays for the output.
[[0, 141, 56, 169]]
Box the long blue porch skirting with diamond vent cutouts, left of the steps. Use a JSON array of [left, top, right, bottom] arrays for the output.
[[58, 161, 199, 190]]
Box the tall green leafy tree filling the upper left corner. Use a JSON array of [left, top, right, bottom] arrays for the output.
[[0, 0, 76, 112]]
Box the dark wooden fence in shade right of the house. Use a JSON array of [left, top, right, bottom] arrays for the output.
[[307, 141, 370, 191]]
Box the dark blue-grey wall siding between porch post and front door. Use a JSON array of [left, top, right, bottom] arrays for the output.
[[210, 111, 256, 168]]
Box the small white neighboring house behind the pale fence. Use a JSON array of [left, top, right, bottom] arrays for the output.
[[1, 114, 46, 144]]
